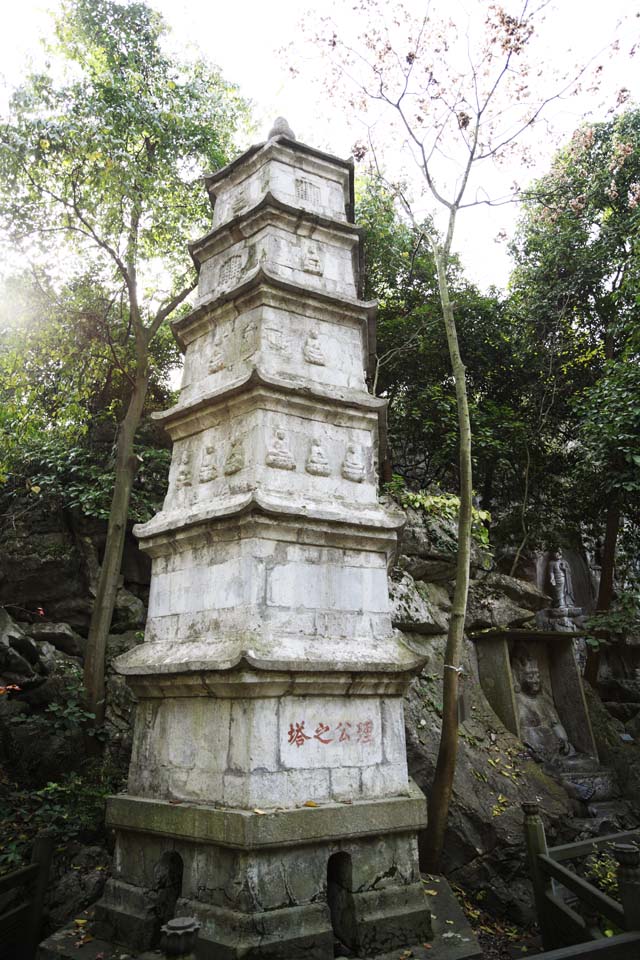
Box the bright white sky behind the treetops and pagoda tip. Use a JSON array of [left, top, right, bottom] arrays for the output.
[[0, 0, 640, 288]]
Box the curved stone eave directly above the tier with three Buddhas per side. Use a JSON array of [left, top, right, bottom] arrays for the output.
[[151, 364, 387, 427]]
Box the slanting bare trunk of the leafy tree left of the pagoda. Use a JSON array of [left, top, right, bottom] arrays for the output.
[[84, 369, 149, 726]]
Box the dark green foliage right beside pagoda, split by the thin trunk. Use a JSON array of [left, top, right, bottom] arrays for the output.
[[356, 177, 521, 501]]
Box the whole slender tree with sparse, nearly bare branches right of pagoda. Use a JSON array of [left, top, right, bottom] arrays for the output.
[[310, 0, 624, 871]]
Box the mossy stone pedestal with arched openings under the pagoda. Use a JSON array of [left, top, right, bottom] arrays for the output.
[[96, 784, 431, 960]]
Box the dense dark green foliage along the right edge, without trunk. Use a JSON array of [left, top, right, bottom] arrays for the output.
[[511, 109, 640, 533]]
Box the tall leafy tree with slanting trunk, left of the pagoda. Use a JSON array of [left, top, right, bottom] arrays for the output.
[[0, 0, 245, 721]]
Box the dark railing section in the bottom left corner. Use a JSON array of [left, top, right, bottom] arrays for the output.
[[0, 834, 53, 960]]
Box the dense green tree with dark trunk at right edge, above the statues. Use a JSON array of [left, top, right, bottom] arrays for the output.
[[512, 109, 640, 682]]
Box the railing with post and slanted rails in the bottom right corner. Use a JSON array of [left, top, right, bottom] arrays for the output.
[[522, 802, 640, 960]]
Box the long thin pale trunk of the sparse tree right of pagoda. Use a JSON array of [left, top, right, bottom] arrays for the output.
[[422, 248, 472, 873]]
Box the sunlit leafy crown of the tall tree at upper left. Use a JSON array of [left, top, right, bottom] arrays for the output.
[[0, 0, 246, 286]]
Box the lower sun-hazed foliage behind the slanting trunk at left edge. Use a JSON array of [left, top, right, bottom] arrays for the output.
[[0, 272, 179, 539]]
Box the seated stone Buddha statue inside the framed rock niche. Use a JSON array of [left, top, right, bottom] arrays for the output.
[[512, 650, 576, 764]]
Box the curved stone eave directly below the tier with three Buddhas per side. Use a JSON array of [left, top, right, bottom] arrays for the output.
[[133, 490, 406, 550]]
